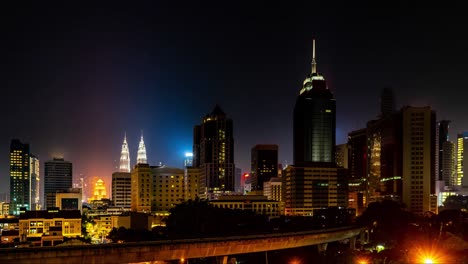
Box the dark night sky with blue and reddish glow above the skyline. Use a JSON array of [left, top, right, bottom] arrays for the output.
[[0, 1, 468, 196]]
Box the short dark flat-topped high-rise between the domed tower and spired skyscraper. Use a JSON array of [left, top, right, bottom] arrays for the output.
[[251, 144, 278, 191]]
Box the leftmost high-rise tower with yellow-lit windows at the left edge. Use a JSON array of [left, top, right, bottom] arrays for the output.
[[10, 139, 31, 215]]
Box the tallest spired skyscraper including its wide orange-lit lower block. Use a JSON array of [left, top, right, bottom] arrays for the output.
[[282, 40, 348, 216]]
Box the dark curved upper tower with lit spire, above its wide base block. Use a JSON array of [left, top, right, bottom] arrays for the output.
[[293, 40, 336, 166]]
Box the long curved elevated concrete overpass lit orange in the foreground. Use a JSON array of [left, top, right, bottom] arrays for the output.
[[0, 227, 368, 264]]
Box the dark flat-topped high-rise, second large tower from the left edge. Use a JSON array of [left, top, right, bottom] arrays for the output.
[[44, 158, 73, 209]]
